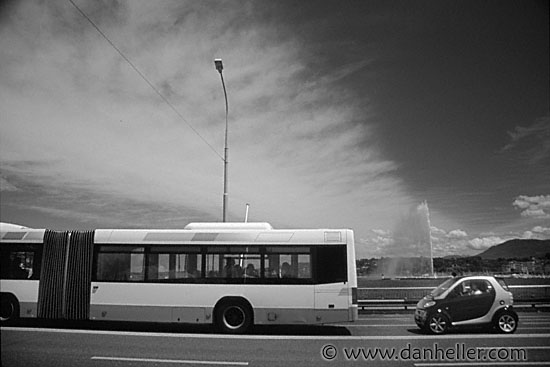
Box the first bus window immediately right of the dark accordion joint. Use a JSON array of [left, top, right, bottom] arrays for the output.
[[95, 246, 145, 282]]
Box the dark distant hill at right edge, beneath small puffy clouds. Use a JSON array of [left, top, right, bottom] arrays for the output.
[[478, 240, 550, 259]]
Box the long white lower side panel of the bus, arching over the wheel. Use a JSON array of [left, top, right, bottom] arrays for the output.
[[90, 282, 316, 324]]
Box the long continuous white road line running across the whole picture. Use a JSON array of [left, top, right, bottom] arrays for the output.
[[4, 327, 550, 340]]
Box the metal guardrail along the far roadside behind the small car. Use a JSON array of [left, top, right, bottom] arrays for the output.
[[357, 285, 550, 311]]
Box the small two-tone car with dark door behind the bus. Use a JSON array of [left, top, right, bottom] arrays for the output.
[[414, 276, 519, 334]]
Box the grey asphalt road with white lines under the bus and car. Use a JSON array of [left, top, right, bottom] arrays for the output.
[[1, 313, 550, 367]]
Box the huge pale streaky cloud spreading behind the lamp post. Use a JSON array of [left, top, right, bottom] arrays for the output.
[[0, 1, 411, 235]]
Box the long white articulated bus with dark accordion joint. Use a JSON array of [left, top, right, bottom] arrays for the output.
[[0, 223, 357, 333]]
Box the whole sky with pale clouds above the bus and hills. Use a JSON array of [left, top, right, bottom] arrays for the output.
[[0, 0, 550, 258]]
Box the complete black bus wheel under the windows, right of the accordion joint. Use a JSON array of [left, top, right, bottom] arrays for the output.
[[214, 298, 253, 334]]
